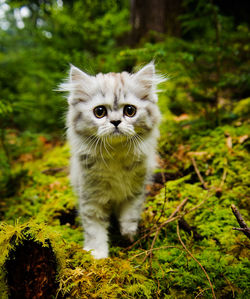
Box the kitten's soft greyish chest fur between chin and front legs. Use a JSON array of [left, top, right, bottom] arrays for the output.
[[81, 156, 147, 201]]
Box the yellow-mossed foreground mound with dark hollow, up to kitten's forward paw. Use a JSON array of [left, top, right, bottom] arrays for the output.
[[0, 221, 155, 299]]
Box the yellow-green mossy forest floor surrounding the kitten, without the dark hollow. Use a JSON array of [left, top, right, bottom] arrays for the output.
[[0, 95, 250, 298]]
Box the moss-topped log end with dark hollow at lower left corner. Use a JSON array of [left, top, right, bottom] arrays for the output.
[[0, 222, 61, 299]]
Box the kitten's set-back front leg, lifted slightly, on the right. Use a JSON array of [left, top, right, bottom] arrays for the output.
[[118, 194, 144, 242]]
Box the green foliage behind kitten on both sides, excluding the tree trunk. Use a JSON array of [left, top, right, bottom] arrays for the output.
[[0, 0, 250, 132]]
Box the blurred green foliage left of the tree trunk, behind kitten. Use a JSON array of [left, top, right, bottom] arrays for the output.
[[0, 0, 129, 132]]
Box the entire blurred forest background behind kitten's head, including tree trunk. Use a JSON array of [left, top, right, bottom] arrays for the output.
[[0, 0, 250, 133]]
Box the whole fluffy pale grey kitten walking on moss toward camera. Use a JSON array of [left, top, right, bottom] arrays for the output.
[[60, 63, 164, 259]]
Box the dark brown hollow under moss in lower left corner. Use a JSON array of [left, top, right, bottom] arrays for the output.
[[5, 240, 58, 299]]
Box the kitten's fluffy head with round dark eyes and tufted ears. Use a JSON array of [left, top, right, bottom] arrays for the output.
[[61, 63, 164, 141]]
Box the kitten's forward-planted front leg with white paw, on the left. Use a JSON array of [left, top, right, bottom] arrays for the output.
[[80, 203, 109, 259]]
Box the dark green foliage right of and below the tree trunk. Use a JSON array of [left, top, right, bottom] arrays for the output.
[[118, 0, 250, 125]]
